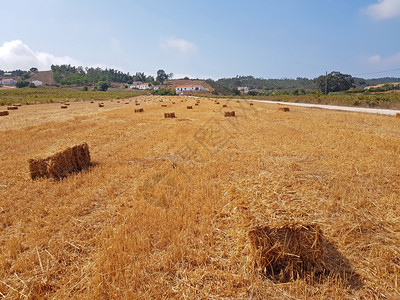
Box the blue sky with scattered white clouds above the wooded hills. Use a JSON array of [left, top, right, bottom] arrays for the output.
[[0, 0, 400, 79]]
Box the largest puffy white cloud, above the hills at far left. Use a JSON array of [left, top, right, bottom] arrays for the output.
[[0, 40, 79, 71]]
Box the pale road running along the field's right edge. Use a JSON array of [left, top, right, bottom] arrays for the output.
[[247, 99, 400, 116]]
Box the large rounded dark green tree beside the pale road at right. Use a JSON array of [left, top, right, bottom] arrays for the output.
[[314, 72, 354, 93]]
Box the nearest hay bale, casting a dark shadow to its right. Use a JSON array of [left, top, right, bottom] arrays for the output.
[[248, 223, 326, 281]]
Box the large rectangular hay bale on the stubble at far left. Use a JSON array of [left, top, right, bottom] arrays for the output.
[[29, 143, 90, 180]]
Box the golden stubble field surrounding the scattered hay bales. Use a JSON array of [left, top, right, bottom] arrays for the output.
[[0, 96, 400, 299]]
